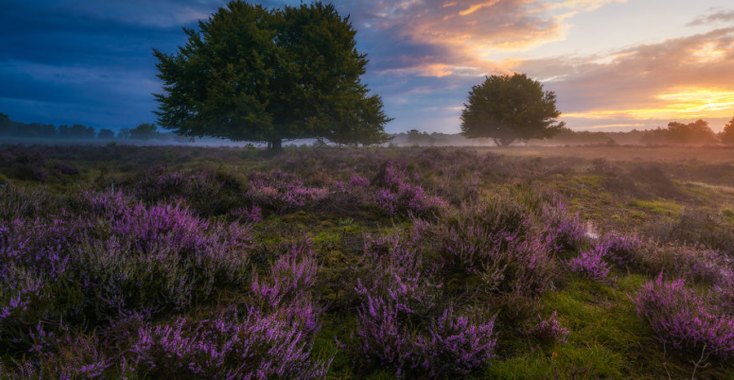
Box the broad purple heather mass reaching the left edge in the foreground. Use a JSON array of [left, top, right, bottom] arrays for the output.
[[0, 193, 253, 344]]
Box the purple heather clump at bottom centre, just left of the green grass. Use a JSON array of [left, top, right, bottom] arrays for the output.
[[355, 235, 495, 377]]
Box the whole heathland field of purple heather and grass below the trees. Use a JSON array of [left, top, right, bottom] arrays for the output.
[[0, 145, 734, 379]]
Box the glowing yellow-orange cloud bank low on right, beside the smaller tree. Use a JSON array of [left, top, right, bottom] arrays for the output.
[[513, 28, 734, 123]]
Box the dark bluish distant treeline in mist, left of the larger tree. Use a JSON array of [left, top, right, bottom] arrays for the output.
[[0, 113, 189, 143]]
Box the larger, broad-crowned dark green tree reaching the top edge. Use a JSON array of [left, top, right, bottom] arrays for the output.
[[154, 1, 390, 149]]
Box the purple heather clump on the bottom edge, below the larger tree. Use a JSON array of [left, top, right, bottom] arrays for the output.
[[128, 309, 330, 380]]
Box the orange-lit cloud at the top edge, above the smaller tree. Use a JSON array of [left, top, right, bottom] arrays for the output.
[[356, 0, 620, 77]]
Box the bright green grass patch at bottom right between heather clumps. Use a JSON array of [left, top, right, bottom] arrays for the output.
[[482, 273, 734, 380]]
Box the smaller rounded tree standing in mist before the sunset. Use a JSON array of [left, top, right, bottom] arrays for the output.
[[461, 74, 565, 146]]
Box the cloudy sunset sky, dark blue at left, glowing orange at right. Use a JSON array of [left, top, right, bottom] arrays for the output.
[[0, 0, 734, 133]]
